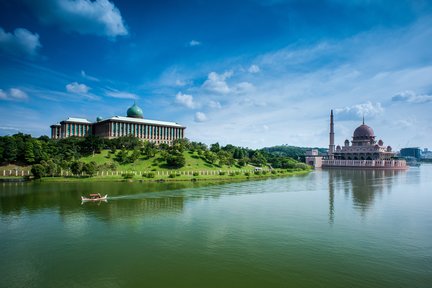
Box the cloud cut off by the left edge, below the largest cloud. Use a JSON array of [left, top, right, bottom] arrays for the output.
[[0, 27, 42, 56]]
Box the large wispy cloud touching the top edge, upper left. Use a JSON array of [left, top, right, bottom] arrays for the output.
[[27, 0, 128, 38]]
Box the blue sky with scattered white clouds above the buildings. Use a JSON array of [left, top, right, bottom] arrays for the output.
[[0, 0, 432, 150]]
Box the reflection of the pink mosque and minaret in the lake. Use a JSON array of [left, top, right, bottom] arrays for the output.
[[328, 169, 405, 223]]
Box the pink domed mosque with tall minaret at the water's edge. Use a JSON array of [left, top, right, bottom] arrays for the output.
[[306, 110, 407, 169]]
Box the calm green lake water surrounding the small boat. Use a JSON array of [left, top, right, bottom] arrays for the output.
[[0, 165, 432, 288]]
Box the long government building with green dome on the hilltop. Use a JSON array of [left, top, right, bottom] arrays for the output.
[[50, 103, 186, 144]]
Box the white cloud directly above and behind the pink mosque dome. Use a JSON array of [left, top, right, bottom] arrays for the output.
[[334, 101, 384, 120]]
